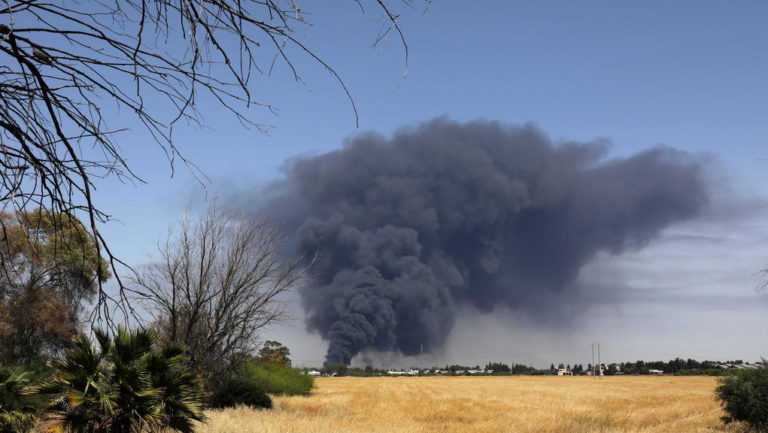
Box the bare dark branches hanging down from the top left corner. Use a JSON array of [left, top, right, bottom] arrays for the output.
[[0, 0, 429, 320]]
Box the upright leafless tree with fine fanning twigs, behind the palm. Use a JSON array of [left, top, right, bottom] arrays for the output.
[[129, 206, 306, 382]]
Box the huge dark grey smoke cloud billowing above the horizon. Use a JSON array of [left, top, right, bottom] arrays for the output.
[[265, 119, 708, 365]]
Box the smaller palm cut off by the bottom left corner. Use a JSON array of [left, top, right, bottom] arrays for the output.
[[0, 368, 36, 433]]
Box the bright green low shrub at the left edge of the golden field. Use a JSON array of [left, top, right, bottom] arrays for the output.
[[242, 362, 315, 395]]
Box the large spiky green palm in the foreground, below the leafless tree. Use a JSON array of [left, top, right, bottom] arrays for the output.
[[40, 328, 203, 433]]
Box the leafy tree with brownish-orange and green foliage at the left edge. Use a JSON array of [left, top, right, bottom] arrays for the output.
[[0, 209, 110, 364]]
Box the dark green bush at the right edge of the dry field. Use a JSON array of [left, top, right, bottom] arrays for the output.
[[715, 361, 768, 432]]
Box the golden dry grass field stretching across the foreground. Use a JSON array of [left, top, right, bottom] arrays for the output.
[[199, 376, 737, 433]]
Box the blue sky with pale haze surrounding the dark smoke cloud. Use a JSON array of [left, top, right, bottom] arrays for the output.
[[91, 0, 768, 365]]
